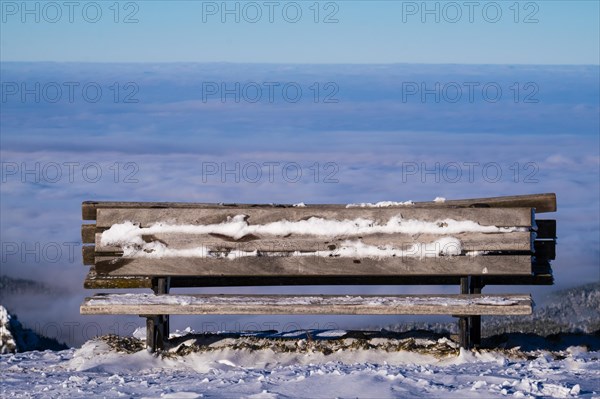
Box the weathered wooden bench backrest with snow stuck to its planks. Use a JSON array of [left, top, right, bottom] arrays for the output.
[[82, 194, 556, 288]]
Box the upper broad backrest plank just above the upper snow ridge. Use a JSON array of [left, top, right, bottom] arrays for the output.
[[96, 206, 533, 227]]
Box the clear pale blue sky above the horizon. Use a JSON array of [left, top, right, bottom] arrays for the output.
[[1, 0, 600, 65]]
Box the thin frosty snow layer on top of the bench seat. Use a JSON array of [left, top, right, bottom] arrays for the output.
[[87, 294, 530, 306]]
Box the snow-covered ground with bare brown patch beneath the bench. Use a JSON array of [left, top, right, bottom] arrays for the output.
[[0, 331, 600, 398]]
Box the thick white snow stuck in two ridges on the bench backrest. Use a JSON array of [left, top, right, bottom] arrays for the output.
[[101, 215, 523, 259]]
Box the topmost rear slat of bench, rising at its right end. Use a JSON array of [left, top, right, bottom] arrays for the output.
[[82, 193, 556, 220]]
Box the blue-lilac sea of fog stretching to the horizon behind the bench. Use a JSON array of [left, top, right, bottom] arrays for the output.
[[0, 63, 600, 344]]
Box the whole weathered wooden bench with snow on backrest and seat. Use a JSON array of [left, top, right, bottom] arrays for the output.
[[81, 194, 556, 351]]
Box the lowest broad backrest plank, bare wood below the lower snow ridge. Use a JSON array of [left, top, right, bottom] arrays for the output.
[[96, 255, 531, 276]]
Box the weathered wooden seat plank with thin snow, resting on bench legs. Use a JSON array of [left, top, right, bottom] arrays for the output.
[[80, 294, 532, 316]]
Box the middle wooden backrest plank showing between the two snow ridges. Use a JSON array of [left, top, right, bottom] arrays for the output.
[[96, 231, 531, 253]]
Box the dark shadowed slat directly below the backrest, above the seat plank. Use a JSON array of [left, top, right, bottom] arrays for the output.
[[84, 266, 554, 289]]
